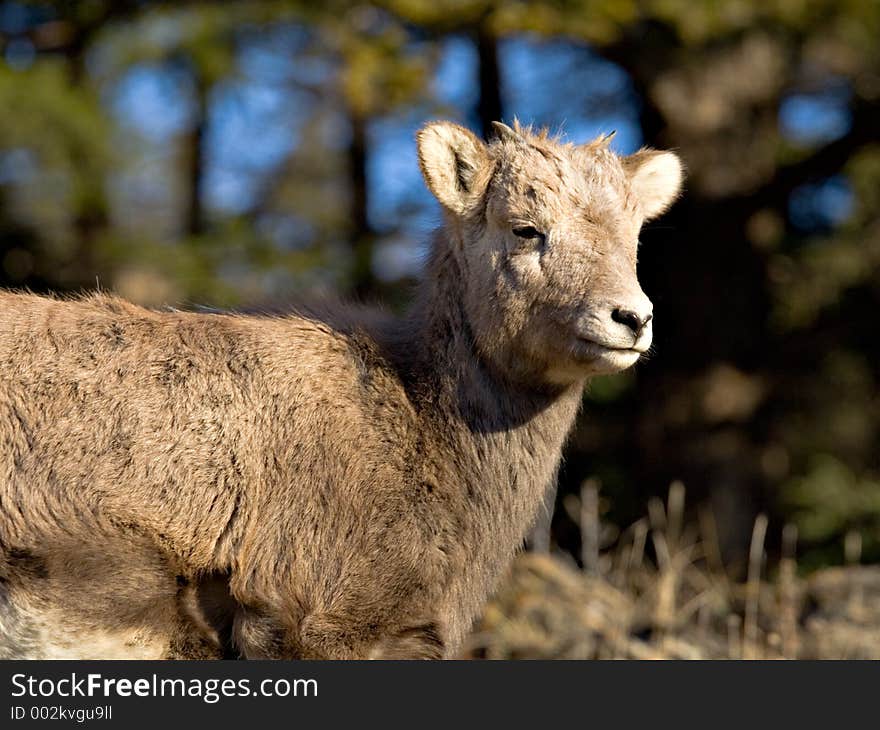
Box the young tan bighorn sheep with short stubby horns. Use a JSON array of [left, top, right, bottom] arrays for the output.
[[0, 122, 682, 658]]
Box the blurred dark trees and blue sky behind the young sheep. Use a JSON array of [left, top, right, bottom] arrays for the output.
[[0, 0, 880, 592]]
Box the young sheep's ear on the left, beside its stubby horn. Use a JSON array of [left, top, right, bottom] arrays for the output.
[[416, 122, 489, 215]]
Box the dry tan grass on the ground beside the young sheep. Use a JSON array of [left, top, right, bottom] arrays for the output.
[[466, 483, 880, 659]]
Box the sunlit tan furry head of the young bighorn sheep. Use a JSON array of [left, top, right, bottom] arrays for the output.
[[422, 119, 681, 383]]
